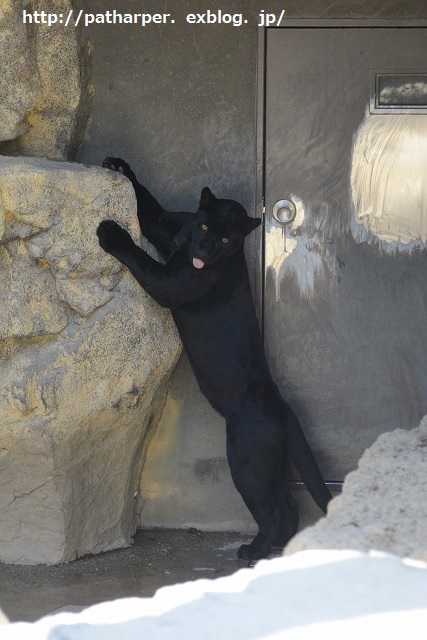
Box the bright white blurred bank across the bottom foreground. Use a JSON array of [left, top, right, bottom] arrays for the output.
[[0, 551, 427, 640]]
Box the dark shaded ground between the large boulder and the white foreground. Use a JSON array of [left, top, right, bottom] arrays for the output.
[[0, 529, 258, 622]]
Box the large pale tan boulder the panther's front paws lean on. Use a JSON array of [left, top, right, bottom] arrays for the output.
[[0, 157, 180, 564]]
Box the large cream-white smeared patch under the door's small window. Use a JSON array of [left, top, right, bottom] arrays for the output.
[[351, 114, 427, 251]]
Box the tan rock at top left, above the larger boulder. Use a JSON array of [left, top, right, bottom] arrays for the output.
[[0, 0, 91, 159]]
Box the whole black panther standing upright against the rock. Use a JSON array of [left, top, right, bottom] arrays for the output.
[[97, 158, 331, 560]]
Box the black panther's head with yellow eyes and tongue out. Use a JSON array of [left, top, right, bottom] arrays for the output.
[[189, 187, 261, 269]]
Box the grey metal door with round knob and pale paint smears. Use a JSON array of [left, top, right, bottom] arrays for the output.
[[264, 27, 427, 481]]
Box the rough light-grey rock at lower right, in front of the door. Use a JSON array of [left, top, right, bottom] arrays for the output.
[[285, 417, 427, 560]]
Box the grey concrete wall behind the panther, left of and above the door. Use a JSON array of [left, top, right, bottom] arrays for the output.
[[78, 0, 427, 530]]
